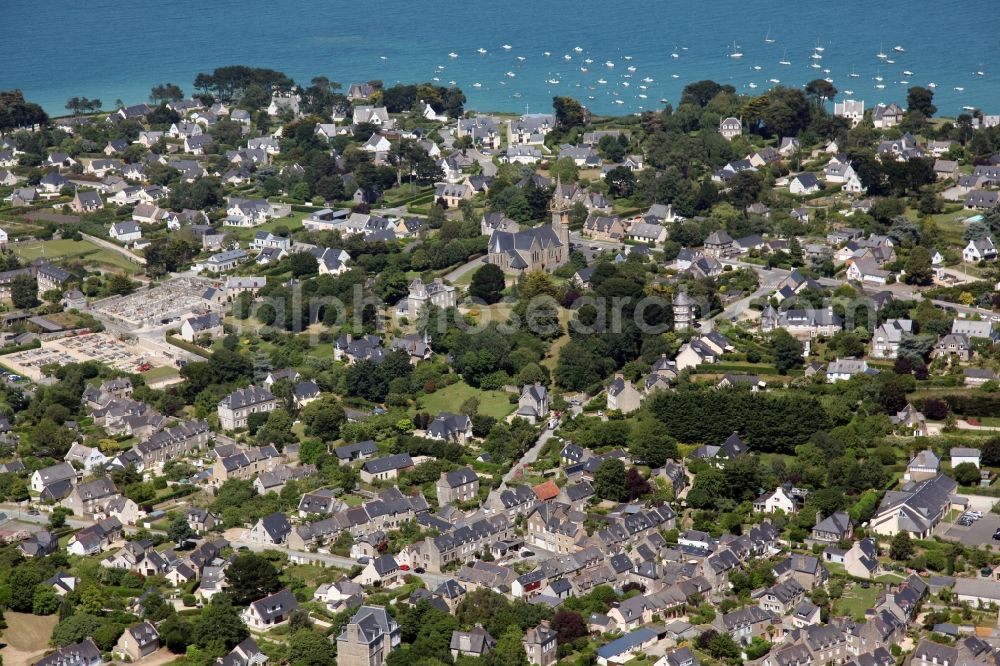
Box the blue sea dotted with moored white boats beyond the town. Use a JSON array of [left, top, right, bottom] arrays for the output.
[[0, 0, 1000, 116]]
